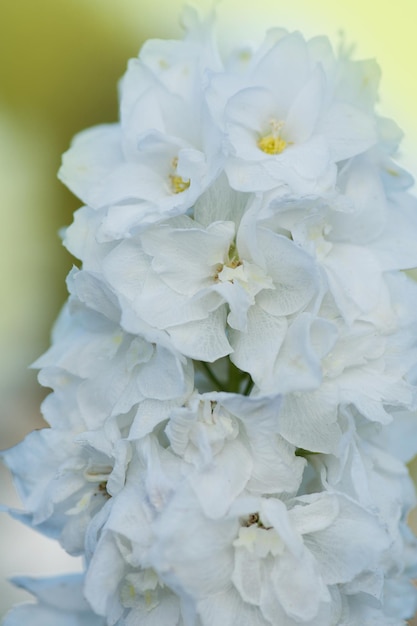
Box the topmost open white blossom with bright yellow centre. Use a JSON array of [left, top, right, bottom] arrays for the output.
[[209, 33, 376, 195]]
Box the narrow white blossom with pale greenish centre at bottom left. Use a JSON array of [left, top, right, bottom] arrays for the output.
[[85, 437, 182, 626]]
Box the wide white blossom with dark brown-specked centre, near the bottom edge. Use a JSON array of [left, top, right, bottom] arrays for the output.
[[150, 460, 390, 624]]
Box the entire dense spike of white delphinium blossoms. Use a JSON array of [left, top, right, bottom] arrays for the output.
[[3, 10, 417, 626]]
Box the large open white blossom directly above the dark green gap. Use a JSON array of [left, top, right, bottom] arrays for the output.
[[103, 176, 320, 364]]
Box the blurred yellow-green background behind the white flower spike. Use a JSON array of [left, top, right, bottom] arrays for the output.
[[0, 0, 417, 615]]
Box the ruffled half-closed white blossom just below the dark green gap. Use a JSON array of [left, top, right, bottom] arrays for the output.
[[166, 393, 304, 518]]
